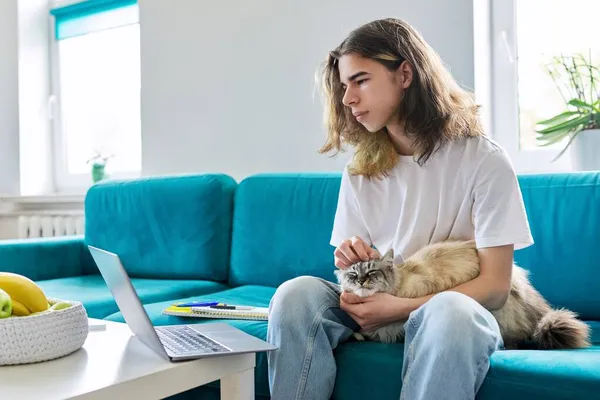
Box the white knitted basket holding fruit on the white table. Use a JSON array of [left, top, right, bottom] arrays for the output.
[[0, 298, 88, 365]]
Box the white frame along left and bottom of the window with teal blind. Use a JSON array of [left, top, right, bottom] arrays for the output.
[[48, 0, 142, 193]]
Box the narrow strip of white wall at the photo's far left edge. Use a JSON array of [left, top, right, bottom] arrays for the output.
[[0, 0, 19, 194]]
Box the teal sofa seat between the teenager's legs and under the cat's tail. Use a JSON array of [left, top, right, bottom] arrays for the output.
[[333, 321, 600, 400]]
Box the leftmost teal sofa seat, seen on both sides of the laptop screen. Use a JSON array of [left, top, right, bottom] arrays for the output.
[[36, 275, 227, 318]]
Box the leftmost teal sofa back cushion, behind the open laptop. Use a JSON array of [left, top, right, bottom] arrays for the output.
[[85, 174, 237, 281]]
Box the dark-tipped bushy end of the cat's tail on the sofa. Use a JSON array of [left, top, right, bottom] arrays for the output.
[[533, 309, 590, 350]]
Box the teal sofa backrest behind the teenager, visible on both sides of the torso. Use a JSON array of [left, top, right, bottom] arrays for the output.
[[229, 173, 600, 319]]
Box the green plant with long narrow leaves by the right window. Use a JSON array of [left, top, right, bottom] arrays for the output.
[[536, 52, 600, 161]]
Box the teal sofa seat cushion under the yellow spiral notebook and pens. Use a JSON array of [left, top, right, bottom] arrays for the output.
[[105, 285, 275, 398]]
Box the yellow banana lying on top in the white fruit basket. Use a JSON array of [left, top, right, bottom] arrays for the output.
[[0, 272, 48, 315]]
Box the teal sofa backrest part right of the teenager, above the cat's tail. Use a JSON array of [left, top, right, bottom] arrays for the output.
[[515, 172, 600, 320]]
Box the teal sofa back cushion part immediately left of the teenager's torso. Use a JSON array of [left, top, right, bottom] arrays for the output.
[[229, 174, 340, 287]]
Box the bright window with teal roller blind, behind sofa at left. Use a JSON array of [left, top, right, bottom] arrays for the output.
[[51, 0, 141, 191]]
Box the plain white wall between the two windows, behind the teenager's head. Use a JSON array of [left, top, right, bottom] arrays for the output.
[[139, 0, 475, 179]]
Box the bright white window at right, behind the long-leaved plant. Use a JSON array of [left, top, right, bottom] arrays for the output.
[[492, 0, 600, 172]]
